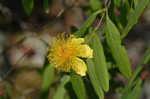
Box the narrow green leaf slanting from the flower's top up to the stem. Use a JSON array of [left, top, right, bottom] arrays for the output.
[[74, 9, 106, 37]]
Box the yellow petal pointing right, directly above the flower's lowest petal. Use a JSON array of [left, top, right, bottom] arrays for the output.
[[77, 45, 93, 58]]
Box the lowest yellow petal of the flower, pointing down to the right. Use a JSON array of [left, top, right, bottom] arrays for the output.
[[71, 57, 87, 76]]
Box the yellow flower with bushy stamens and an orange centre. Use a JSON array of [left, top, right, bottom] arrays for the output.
[[48, 35, 93, 76]]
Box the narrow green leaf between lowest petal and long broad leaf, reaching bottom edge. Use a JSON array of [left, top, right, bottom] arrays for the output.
[[86, 59, 104, 99]]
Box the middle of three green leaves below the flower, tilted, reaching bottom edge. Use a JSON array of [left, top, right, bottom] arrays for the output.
[[53, 76, 70, 99]]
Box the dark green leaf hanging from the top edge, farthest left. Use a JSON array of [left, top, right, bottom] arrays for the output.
[[22, 0, 34, 15]]
